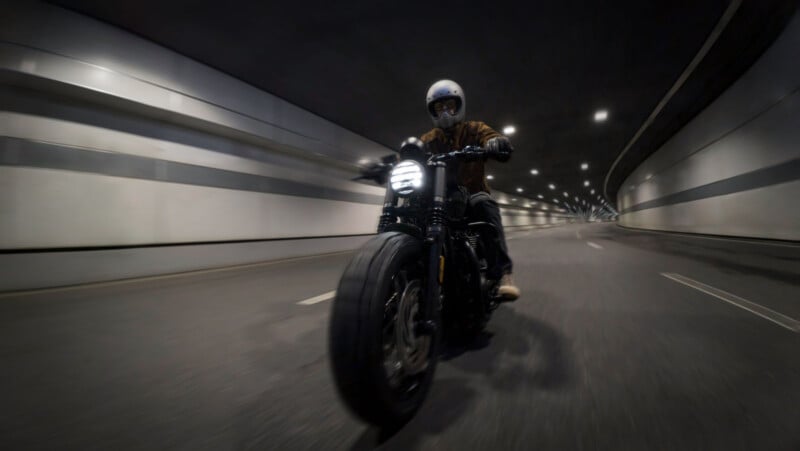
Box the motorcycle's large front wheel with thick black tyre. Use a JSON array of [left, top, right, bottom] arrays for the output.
[[329, 232, 439, 426]]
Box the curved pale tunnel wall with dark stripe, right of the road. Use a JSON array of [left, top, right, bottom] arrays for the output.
[[617, 9, 800, 240]]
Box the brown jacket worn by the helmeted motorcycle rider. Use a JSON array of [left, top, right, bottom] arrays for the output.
[[420, 121, 502, 194]]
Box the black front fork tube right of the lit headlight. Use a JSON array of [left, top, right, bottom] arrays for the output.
[[425, 162, 446, 320]]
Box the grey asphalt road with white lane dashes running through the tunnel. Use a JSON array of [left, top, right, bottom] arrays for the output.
[[0, 224, 800, 450]]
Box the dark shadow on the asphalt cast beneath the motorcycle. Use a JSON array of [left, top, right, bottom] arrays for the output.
[[351, 307, 576, 450]]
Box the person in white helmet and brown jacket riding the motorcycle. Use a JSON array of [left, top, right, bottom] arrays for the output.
[[420, 80, 520, 301]]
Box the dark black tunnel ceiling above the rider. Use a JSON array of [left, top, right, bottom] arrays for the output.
[[54, 0, 796, 208]]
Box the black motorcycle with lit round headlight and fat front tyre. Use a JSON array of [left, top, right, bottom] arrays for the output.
[[329, 138, 499, 426]]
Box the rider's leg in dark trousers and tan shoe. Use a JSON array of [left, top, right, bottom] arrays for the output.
[[469, 191, 519, 300]]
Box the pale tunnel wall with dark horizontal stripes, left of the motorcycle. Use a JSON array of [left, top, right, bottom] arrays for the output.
[[0, 2, 563, 291]]
